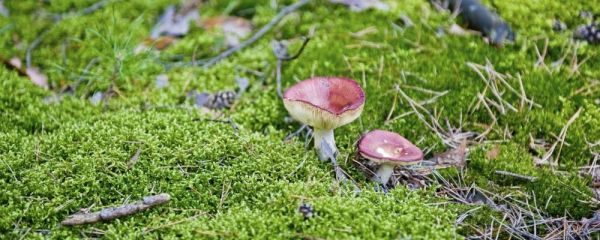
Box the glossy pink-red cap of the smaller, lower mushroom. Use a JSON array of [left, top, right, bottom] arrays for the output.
[[358, 130, 423, 165]]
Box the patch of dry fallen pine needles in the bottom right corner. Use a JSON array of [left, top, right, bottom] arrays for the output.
[[431, 172, 600, 240]]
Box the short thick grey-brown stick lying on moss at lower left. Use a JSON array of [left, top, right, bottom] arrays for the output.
[[60, 193, 171, 226]]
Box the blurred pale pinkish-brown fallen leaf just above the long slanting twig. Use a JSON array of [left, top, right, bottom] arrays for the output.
[[203, 16, 253, 47]]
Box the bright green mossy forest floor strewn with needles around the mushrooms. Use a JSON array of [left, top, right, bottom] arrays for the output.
[[0, 0, 600, 239]]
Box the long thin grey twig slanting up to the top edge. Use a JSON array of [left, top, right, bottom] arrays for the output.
[[202, 0, 311, 68]]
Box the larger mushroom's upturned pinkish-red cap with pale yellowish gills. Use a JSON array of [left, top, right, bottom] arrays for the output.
[[283, 77, 365, 129]]
